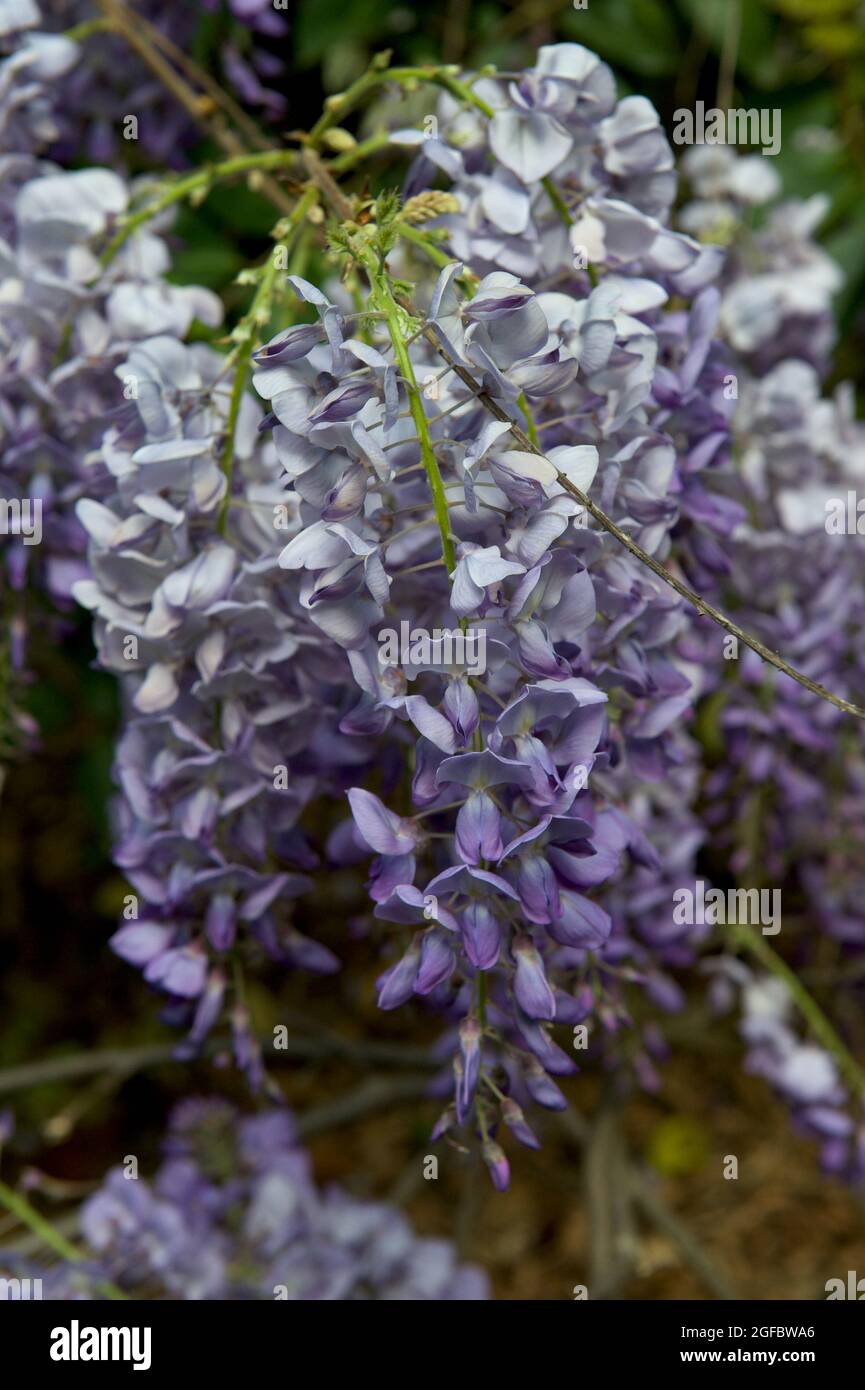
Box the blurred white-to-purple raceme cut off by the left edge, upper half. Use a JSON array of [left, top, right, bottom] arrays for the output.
[[0, 141, 230, 767]]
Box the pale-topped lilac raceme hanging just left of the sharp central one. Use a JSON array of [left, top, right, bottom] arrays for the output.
[[75, 328, 375, 1081]]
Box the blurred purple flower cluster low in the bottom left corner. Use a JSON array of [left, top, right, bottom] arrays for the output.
[[0, 1098, 488, 1302]]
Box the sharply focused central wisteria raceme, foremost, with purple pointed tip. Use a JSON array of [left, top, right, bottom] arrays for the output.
[[254, 154, 723, 1186]]
